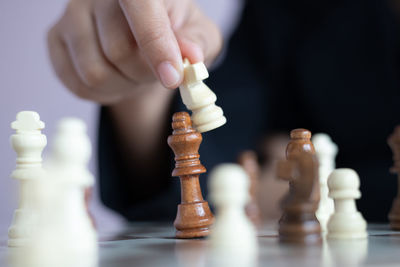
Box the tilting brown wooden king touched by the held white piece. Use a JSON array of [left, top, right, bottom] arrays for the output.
[[168, 112, 214, 238]]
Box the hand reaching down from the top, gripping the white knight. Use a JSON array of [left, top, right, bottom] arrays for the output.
[[48, 0, 222, 104]]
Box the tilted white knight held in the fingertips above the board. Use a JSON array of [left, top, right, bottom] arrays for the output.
[[179, 59, 226, 133]]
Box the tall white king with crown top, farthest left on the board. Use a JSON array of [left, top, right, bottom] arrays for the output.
[[8, 111, 47, 247]]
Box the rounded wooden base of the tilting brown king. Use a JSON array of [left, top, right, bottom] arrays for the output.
[[174, 201, 214, 238]]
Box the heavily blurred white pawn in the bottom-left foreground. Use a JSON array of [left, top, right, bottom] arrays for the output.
[[10, 176, 97, 267]]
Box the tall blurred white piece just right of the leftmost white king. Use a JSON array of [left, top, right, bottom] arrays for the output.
[[46, 118, 97, 254]]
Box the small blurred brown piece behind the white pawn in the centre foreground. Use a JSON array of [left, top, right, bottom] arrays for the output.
[[238, 150, 261, 227]]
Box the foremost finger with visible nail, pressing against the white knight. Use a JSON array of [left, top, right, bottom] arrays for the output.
[[120, 0, 183, 88]]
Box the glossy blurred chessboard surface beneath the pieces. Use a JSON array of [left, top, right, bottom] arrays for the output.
[[0, 223, 400, 267]]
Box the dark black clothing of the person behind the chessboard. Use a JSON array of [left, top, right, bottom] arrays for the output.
[[99, 0, 400, 221]]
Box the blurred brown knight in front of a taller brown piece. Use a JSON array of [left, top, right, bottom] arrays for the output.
[[277, 151, 322, 244]]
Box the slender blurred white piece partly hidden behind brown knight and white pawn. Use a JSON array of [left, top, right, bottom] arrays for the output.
[[312, 133, 338, 232]]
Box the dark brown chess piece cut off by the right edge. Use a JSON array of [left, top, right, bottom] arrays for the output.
[[388, 125, 400, 230]]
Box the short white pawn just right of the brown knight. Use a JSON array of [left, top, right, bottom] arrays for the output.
[[327, 169, 367, 239]]
